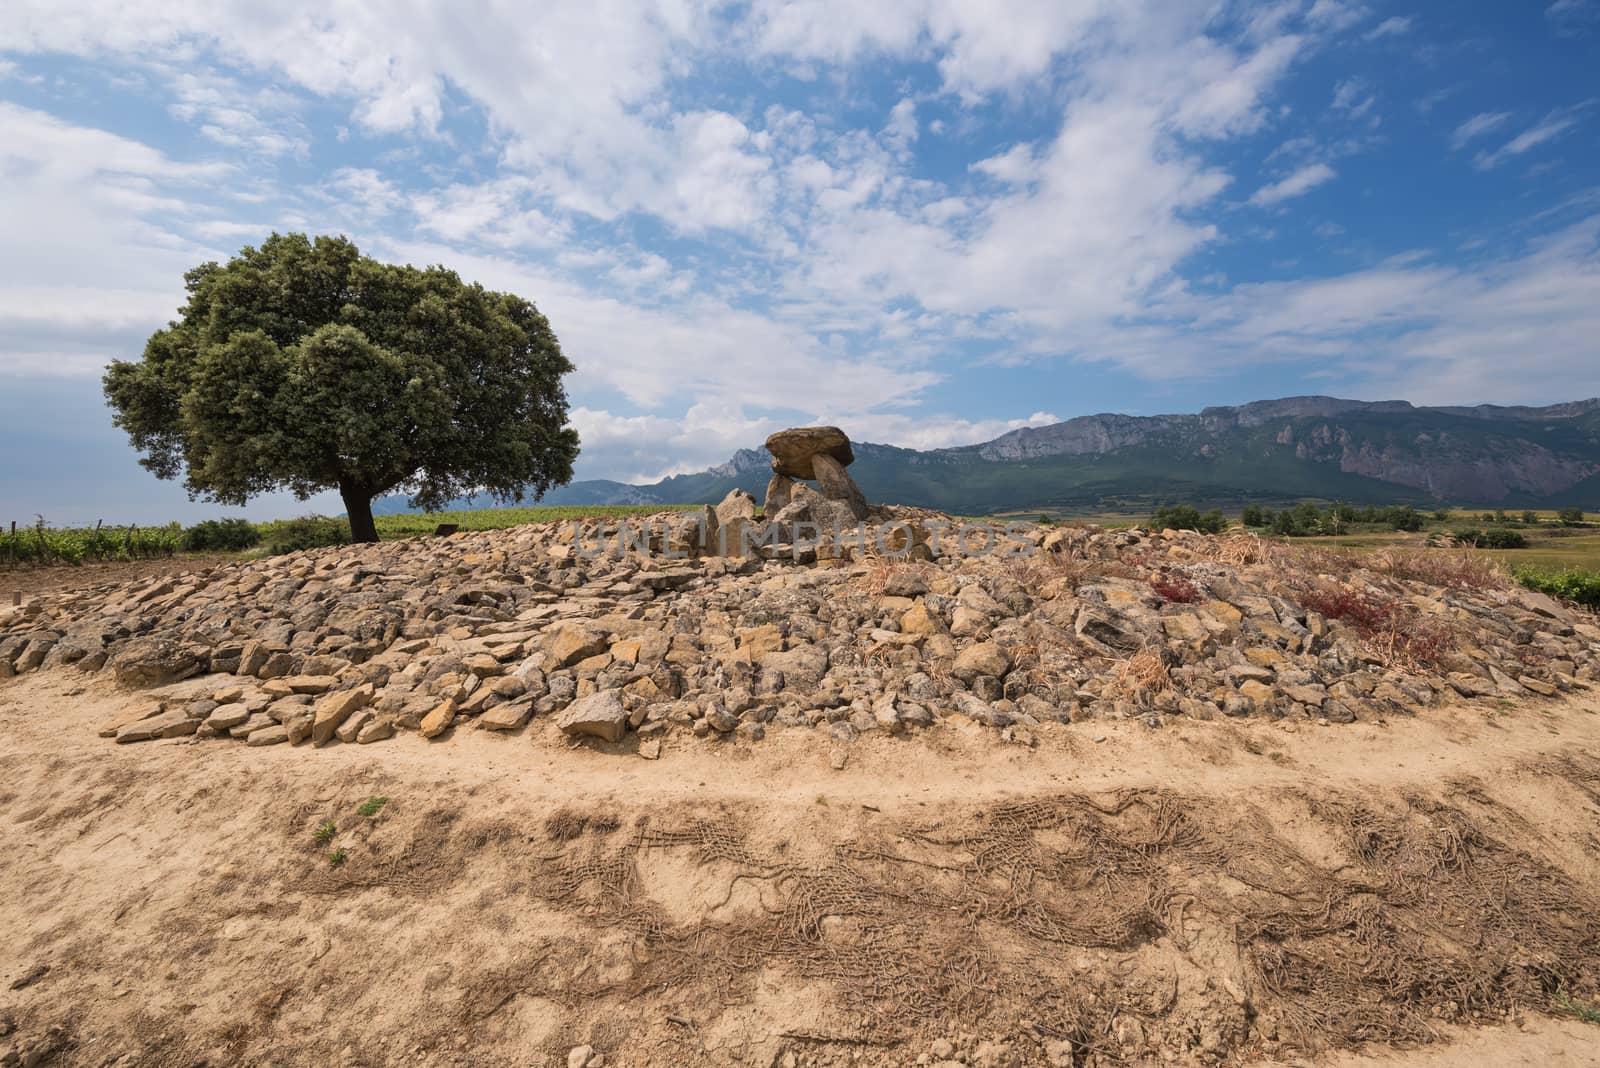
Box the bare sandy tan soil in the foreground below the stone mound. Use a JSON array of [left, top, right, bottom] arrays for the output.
[[0, 671, 1600, 1068]]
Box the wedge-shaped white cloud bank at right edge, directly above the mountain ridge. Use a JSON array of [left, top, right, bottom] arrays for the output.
[[1126, 216, 1600, 403]]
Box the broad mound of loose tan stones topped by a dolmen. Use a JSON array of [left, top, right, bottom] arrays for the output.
[[0, 427, 1600, 758]]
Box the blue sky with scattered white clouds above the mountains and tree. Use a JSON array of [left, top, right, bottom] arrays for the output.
[[0, 0, 1600, 523]]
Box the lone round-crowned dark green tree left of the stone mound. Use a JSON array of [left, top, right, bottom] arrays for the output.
[[106, 233, 578, 542]]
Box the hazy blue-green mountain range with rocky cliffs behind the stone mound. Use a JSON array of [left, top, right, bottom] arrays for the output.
[[374, 397, 1600, 515]]
